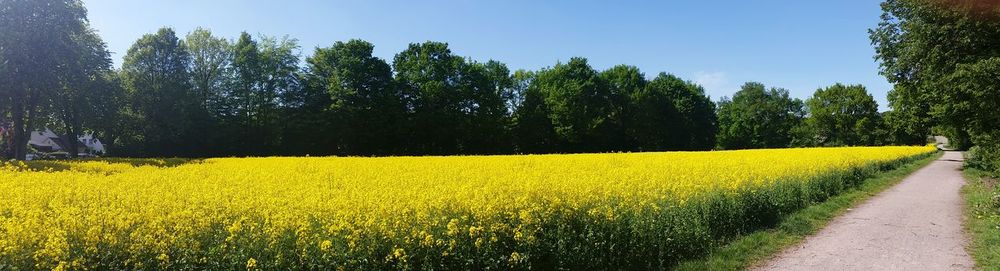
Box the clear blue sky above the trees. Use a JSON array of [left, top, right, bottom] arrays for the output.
[[84, 0, 892, 110]]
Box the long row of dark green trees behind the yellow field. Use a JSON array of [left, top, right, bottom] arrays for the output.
[[0, 0, 926, 159]]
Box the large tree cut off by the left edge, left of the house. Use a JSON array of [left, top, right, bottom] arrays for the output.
[[0, 0, 88, 160]]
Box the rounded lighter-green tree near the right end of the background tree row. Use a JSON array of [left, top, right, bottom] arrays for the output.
[[806, 83, 884, 146]]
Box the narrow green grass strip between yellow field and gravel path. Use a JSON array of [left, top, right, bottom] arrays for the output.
[[677, 152, 944, 270]]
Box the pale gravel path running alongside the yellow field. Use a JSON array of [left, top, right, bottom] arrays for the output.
[[756, 152, 974, 271]]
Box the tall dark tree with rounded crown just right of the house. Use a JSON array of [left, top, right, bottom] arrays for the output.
[[122, 28, 201, 157]]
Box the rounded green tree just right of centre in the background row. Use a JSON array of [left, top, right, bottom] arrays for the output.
[[533, 57, 622, 152]]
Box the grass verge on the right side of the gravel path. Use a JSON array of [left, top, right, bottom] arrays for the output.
[[962, 168, 1000, 270]]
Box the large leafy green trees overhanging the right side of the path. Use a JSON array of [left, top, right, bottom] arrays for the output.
[[870, 0, 1000, 174]]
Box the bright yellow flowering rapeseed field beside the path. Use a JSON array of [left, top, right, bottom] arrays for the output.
[[0, 147, 935, 270]]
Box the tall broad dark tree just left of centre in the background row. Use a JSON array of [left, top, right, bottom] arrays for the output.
[[393, 42, 511, 154]]
